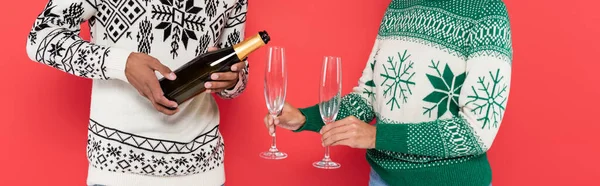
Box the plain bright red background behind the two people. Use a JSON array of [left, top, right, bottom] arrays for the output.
[[0, 0, 600, 186]]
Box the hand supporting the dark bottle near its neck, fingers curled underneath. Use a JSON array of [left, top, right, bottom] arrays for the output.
[[204, 47, 246, 92]]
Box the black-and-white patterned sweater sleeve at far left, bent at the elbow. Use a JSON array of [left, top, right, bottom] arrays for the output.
[[27, 0, 132, 81]]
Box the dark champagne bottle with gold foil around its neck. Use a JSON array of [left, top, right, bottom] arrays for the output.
[[159, 31, 271, 109]]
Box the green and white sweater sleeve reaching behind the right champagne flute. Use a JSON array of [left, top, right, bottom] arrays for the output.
[[295, 40, 379, 132]]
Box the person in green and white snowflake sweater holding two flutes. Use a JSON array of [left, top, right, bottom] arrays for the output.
[[265, 0, 512, 186]]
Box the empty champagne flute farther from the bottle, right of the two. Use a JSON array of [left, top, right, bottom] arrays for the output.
[[313, 56, 342, 169]]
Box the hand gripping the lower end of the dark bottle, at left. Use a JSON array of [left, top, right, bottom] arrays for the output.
[[125, 53, 179, 115]]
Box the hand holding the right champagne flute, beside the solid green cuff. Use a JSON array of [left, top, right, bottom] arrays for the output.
[[321, 116, 377, 149]]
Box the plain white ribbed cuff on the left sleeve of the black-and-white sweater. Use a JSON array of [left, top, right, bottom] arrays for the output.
[[104, 48, 132, 83]]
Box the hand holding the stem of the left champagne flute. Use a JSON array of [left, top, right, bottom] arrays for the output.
[[264, 102, 306, 135]]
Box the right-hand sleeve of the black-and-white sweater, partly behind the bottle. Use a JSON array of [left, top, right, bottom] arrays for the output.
[[217, 0, 250, 99]]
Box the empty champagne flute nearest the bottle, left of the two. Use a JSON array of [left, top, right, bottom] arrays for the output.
[[260, 46, 287, 160]]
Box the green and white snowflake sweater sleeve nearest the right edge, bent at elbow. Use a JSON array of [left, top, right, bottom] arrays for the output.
[[375, 1, 512, 157]]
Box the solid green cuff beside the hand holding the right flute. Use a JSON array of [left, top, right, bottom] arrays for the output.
[[375, 124, 408, 152]]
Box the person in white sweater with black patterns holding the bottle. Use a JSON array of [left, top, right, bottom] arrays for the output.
[[27, 0, 248, 186]]
